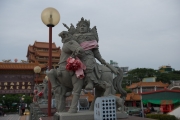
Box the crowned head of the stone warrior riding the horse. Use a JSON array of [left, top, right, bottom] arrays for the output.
[[77, 17, 90, 33]]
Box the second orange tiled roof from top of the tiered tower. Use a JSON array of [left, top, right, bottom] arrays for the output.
[[35, 51, 60, 57]]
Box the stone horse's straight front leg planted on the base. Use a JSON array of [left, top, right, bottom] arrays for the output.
[[68, 75, 83, 113]]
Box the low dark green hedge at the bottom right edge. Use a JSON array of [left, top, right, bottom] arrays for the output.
[[146, 114, 177, 120]]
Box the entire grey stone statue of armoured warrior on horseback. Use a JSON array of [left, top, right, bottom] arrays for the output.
[[47, 18, 126, 113]]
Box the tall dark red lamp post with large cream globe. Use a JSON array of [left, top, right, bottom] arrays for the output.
[[41, 7, 60, 116]]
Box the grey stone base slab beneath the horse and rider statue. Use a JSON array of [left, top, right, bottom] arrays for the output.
[[53, 111, 128, 120]]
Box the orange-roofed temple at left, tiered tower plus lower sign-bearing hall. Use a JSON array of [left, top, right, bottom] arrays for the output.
[[0, 41, 61, 94]]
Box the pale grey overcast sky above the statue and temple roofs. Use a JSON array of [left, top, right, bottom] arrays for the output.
[[0, 0, 180, 70]]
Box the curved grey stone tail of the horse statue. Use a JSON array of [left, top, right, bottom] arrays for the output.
[[113, 67, 127, 100]]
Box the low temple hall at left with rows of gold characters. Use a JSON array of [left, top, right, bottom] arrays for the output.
[[0, 62, 46, 94]]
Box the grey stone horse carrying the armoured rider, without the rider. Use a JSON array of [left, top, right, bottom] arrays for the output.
[[47, 35, 126, 113]]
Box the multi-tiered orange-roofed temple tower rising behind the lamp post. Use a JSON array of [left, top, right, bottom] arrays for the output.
[[26, 41, 61, 68]]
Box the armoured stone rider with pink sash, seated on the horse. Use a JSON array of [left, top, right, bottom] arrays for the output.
[[72, 18, 106, 90]]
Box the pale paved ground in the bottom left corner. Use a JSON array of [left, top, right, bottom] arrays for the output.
[[0, 114, 29, 120]]
